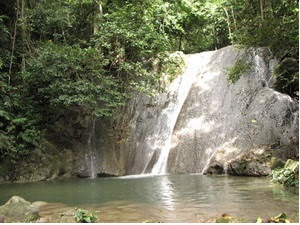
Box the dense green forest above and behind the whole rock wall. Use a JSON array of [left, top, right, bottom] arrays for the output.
[[0, 0, 299, 165]]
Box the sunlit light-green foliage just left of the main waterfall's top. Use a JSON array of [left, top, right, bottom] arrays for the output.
[[93, 1, 170, 95]]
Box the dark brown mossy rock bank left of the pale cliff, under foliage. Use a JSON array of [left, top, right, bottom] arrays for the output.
[[0, 120, 124, 182]]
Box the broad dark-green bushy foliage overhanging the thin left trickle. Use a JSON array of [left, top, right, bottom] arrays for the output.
[[22, 43, 125, 123]]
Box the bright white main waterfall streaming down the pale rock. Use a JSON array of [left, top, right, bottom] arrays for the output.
[[151, 52, 213, 175]]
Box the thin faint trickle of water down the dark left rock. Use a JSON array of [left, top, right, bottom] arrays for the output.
[[85, 119, 97, 178]]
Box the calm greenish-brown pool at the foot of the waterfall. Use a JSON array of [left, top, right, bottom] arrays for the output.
[[0, 175, 299, 222]]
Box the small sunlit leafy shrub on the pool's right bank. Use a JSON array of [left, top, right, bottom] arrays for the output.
[[271, 159, 299, 187]]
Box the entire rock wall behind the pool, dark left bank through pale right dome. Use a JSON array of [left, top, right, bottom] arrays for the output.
[[0, 46, 299, 181]]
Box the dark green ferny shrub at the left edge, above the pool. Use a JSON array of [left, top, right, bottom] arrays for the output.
[[0, 72, 40, 163]]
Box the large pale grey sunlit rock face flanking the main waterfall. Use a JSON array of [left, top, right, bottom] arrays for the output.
[[122, 46, 298, 175]]
